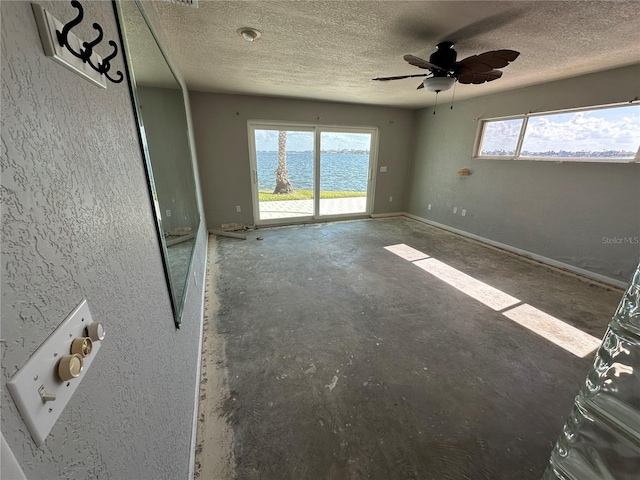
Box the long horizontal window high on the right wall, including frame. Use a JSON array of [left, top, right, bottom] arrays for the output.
[[475, 104, 640, 163]]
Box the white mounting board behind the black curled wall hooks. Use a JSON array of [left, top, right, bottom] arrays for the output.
[[31, 3, 107, 88]]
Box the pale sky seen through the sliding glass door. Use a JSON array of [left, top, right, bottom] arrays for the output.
[[255, 130, 371, 152]]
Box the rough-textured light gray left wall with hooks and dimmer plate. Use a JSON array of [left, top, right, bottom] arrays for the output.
[[0, 1, 206, 479]]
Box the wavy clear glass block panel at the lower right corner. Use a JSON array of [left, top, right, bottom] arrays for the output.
[[543, 265, 640, 480]]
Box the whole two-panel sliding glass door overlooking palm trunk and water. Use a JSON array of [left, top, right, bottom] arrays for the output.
[[249, 122, 377, 225]]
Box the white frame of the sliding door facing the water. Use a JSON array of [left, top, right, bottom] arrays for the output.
[[247, 120, 379, 226]]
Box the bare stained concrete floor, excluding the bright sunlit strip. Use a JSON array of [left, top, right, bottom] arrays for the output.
[[200, 217, 622, 480]]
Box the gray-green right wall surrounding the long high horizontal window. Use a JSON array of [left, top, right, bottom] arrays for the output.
[[406, 65, 640, 282]]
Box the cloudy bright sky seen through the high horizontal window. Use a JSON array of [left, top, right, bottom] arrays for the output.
[[483, 105, 640, 153]]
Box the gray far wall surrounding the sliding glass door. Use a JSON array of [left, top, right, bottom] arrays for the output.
[[190, 92, 414, 228]]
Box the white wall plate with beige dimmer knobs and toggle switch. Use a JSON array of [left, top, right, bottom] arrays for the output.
[[7, 300, 104, 447]]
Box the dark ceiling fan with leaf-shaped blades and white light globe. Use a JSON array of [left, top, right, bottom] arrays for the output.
[[373, 42, 520, 93]]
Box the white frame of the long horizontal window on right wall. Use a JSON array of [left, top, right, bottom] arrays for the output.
[[472, 100, 640, 164]]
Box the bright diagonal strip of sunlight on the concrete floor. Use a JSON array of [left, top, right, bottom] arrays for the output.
[[384, 243, 600, 357]]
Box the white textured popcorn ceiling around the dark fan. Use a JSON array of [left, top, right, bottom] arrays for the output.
[[146, 0, 640, 108]]
